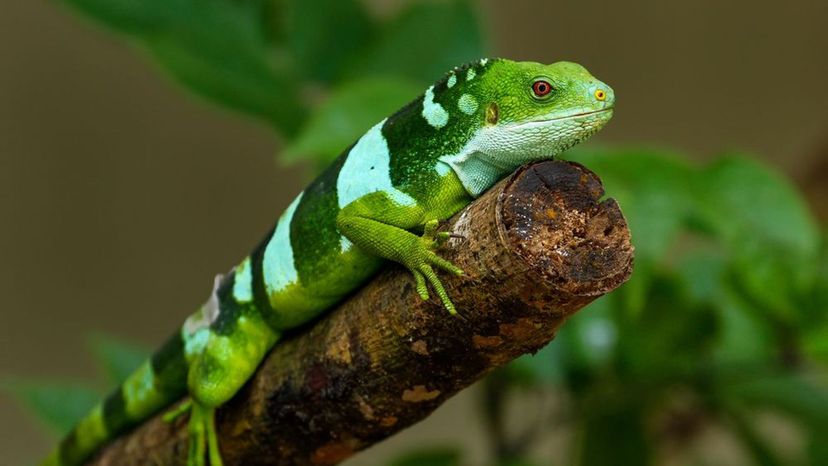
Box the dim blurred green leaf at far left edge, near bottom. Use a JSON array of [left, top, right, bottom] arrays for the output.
[[2, 379, 101, 435]]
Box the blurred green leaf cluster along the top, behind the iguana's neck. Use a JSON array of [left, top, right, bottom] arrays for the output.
[[56, 0, 485, 169]]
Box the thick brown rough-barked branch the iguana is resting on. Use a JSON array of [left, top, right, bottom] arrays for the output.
[[91, 162, 633, 466]]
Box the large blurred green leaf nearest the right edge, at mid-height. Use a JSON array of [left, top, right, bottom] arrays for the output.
[[699, 156, 820, 323]]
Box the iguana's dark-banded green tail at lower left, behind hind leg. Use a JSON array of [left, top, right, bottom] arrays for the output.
[[40, 332, 187, 466]]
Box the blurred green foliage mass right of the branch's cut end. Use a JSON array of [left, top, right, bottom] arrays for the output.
[[484, 147, 828, 465]]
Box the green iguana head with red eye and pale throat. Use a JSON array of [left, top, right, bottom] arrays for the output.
[[441, 59, 615, 195]]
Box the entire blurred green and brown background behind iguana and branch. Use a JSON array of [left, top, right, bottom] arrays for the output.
[[0, 0, 828, 466]]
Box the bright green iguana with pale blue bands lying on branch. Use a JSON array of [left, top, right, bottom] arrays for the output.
[[43, 59, 615, 466]]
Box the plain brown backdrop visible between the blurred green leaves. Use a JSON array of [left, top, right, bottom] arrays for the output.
[[0, 0, 828, 465]]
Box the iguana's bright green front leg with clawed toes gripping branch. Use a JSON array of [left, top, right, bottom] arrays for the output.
[[336, 191, 463, 314]]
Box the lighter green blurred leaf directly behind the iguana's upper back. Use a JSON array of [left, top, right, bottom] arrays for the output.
[[282, 78, 420, 167]]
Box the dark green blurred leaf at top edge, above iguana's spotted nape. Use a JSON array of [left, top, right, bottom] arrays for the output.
[[349, 0, 485, 85]]
